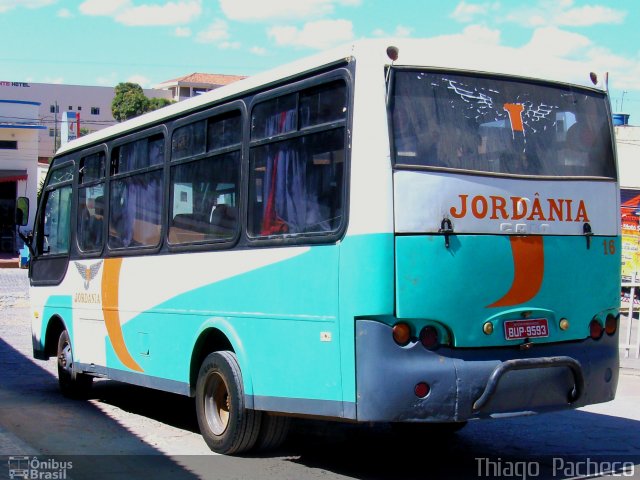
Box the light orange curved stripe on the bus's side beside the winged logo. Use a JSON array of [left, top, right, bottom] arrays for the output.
[[102, 258, 143, 372]]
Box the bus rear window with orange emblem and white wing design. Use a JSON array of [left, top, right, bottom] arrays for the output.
[[390, 69, 616, 178]]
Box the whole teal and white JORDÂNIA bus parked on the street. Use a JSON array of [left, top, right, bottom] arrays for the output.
[[23, 41, 620, 454]]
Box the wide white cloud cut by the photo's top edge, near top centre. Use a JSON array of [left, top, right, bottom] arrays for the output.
[[220, 0, 361, 21]]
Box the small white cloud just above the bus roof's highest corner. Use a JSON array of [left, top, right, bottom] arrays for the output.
[[267, 20, 354, 49]]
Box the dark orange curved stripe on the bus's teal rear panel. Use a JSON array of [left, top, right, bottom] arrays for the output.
[[487, 237, 544, 308]]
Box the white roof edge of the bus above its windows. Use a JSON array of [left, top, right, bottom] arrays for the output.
[[57, 36, 606, 155]]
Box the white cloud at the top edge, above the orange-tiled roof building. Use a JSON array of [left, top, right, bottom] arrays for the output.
[[115, 0, 202, 26]]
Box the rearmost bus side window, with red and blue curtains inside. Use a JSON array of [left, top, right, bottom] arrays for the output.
[[249, 80, 347, 236]]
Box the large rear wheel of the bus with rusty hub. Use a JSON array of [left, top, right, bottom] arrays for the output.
[[196, 351, 262, 455]]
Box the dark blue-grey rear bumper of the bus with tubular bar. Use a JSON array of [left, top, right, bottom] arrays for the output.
[[356, 320, 619, 422]]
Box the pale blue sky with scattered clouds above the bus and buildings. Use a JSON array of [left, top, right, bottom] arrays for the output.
[[0, 0, 640, 125]]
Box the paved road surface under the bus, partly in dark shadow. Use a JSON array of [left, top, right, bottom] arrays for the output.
[[0, 270, 640, 480]]
